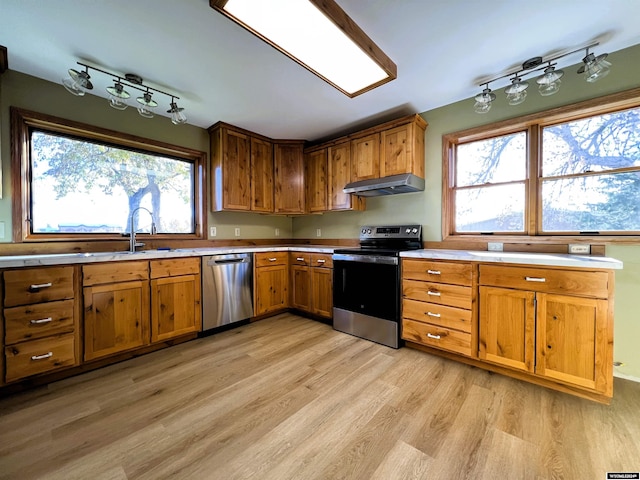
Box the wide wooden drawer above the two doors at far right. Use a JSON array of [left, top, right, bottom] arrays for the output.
[[480, 265, 609, 298]]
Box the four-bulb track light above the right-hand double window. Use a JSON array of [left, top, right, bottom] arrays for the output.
[[473, 42, 611, 113]]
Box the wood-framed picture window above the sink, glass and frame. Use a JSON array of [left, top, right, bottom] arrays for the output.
[[12, 110, 204, 241]]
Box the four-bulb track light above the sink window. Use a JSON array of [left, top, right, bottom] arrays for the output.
[[62, 62, 187, 125]]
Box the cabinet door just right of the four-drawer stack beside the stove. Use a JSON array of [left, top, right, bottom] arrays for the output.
[[478, 287, 535, 372]]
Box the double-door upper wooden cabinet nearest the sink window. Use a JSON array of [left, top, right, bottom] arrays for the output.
[[209, 122, 273, 213]]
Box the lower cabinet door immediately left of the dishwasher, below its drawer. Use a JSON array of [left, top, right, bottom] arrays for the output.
[[151, 275, 202, 342]]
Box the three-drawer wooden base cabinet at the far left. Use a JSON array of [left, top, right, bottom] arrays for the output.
[[0, 266, 80, 383]]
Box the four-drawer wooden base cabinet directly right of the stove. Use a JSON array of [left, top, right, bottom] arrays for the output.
[[402, 259, 478, 357]]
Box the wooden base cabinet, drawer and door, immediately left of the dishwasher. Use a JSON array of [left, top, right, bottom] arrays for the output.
[[150, 258, 202, 343]]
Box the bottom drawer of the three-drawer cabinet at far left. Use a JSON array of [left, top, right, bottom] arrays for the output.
[[4, 333, 77, 382]]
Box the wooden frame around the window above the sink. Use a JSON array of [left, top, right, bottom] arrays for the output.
[[11, 107, 207, 243]]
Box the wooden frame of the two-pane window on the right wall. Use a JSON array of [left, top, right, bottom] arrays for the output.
[[442, 88, 640, 243]]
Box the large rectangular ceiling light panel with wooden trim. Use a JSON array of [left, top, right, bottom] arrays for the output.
[[210, 0, 396, 97]]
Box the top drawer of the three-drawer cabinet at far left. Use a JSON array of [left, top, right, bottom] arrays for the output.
[[4, 267, 74, 307]]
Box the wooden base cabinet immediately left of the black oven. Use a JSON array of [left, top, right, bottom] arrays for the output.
[[289, 252, 333, 318]]
